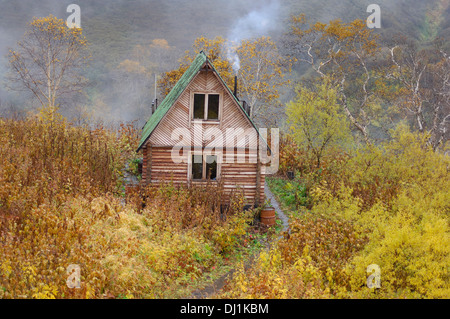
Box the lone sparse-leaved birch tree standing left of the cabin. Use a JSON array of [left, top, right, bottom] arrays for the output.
[[8, 15, 89, 117]]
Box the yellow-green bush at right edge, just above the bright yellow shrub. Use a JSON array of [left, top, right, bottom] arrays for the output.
[[342, 125, 448, 208]]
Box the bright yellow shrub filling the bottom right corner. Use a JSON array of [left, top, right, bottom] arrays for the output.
[[346, 202, 450, 298]]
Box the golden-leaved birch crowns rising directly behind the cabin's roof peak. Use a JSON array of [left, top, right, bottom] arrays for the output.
[[159, 37, 292, 124]]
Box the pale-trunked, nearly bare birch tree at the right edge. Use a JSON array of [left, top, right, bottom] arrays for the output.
[[386, 42, 450, 150]]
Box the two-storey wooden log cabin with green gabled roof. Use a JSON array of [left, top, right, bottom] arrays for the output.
[[137, 51, 270, 206]]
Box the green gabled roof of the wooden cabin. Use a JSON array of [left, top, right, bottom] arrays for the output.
[[136, 51, 272, 153]]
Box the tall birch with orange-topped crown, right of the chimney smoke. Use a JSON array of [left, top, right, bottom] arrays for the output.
[[285, 15, 379, 143]]
